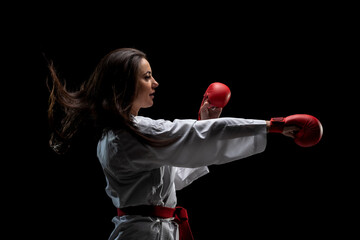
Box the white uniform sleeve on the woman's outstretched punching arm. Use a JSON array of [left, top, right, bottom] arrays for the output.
[[122, 118, 266, 168]]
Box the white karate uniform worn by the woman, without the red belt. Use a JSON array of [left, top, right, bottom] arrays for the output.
[[97, 116, 266, 240]]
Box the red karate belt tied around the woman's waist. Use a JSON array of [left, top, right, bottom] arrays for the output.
[[117, 205, 194, 240]]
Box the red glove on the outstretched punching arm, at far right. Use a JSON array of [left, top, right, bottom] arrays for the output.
[[269, 114, 323, 147]]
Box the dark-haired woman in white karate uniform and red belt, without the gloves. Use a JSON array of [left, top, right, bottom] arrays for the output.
[[48, 48, 296, 240]]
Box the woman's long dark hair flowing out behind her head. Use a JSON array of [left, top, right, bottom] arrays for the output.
[[48, 48, 163, 154]]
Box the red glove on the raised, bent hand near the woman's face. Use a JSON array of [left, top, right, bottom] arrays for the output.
[[199, 82, 231, 119]]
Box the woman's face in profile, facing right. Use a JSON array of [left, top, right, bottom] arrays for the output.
[[132, 58, 159, 116]]
